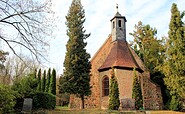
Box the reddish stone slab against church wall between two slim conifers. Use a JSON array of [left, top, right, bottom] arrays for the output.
[[121, 98, 135, 109]]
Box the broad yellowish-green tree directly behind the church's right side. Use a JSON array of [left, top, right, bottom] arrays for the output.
[[130, 21, 169, 104]]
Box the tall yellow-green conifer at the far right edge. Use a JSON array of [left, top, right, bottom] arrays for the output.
[[162, 3, 185, 110]]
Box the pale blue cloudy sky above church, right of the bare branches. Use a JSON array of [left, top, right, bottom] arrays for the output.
[[47, 0, 185, 74]]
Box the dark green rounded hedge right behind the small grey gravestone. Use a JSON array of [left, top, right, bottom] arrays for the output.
[[30, 92, 56, 110]]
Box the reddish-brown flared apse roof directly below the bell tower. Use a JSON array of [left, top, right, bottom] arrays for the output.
[[98, 40, 142, 71]]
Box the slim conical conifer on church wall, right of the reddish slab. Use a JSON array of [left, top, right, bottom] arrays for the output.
[[132, 68, 143, 110]]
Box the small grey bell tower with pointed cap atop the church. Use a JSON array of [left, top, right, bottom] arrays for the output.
[[110, 5, 127, 42]]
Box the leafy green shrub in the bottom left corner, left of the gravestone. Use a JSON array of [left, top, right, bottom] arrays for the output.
[[0, 84, 17, 114]]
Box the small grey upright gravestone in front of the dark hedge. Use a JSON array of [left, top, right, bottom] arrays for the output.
[[22, 98, 33, 112]]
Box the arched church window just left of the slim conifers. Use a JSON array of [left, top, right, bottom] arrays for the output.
[[102, 76, 109, 96]]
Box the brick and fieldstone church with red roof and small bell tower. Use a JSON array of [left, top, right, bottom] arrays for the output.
[[70, 6, 163, 109]]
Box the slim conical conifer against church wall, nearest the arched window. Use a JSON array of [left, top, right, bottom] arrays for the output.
[[109, 68, 120, 110]]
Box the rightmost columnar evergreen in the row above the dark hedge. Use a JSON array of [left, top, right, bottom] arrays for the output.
[[49, 69, 56, 95]]
